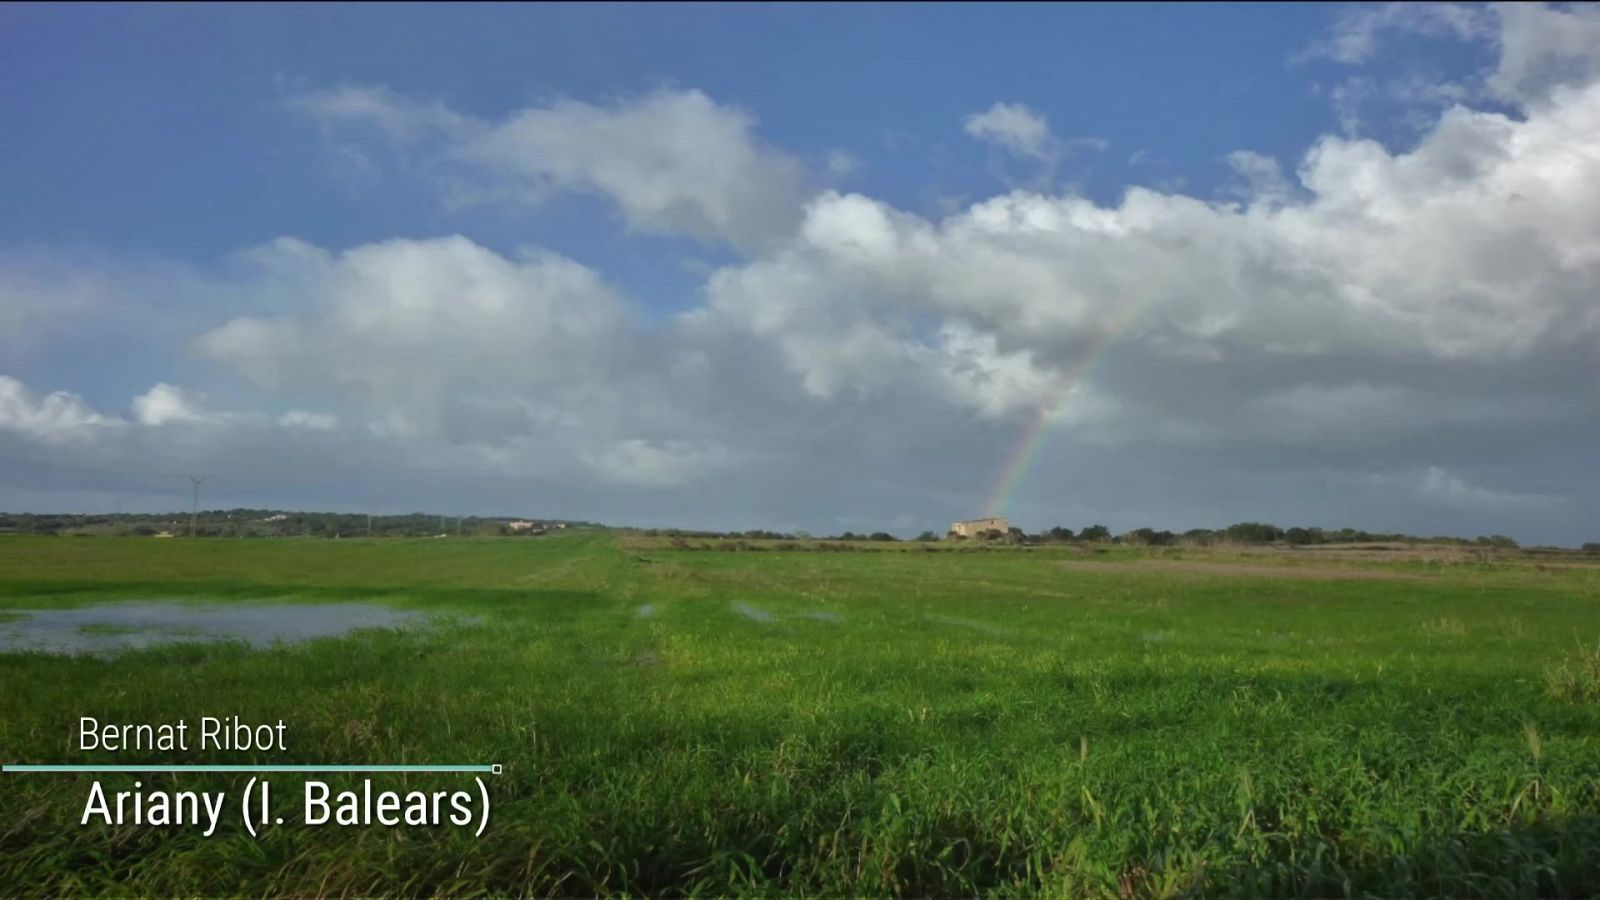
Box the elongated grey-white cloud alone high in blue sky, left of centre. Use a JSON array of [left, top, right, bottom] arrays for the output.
[[288, 85, 806, 248]]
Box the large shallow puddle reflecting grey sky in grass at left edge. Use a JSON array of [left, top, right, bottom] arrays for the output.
[[0, 602, 427, 653]]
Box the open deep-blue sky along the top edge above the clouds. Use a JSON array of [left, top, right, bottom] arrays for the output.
[[0, 5, 1376, 256]]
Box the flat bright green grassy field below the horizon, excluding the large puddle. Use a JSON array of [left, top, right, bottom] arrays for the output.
[[0, 533, 1600, 897]]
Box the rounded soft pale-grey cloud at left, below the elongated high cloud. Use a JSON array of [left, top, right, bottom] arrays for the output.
[[195, 237, 630, 432]]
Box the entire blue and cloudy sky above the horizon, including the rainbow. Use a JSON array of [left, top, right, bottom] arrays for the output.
[[0, 3, 1600, 546]]
